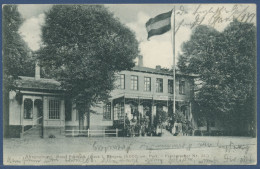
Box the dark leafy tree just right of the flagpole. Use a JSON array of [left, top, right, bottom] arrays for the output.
[[178, 25, 221, 133]]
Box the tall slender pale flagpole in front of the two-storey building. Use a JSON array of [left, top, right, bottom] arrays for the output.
[[171, 6, 176, 114]]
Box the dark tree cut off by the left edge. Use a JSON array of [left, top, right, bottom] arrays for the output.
[[2, 5, 34, 136]]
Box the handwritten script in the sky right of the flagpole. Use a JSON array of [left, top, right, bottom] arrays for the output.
[[175, 4, 256, 32]]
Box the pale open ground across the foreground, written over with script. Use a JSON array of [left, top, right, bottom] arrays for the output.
[[3, 136, 257, 165]]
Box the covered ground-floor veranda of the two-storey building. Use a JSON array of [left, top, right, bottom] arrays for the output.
[[104, 93, 192, 129]]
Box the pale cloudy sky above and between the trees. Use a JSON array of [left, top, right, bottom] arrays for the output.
[[18, 4, 256, 68]]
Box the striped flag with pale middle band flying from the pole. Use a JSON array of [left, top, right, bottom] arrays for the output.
[[145, 10, 172, 39]]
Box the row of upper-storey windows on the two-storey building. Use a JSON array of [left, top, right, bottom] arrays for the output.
[[119, 74, 185, 94]]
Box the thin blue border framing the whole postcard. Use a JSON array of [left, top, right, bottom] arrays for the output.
[[0, 0, 260, 169]]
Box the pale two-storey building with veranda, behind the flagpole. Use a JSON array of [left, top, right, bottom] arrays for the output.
[[100, 66, 195, 132]]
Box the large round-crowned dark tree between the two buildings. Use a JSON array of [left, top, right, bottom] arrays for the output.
[[39, 5, 138, 129]]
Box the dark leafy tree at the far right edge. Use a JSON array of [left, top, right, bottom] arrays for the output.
[[220, 20, 257, 136]]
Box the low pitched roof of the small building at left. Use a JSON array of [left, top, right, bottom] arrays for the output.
[[16, 76, 62, 90]]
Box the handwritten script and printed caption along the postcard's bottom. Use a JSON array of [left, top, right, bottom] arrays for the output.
[[4, 141, 256, 165]]
